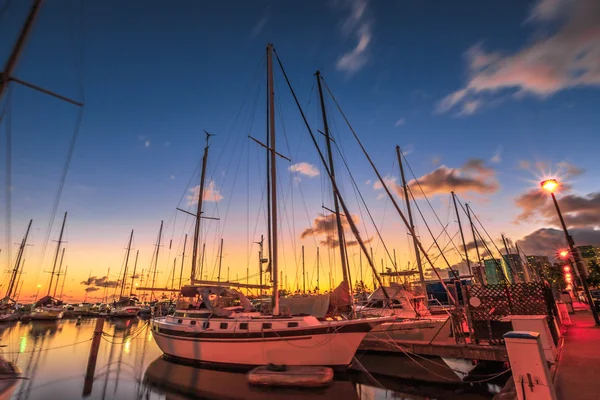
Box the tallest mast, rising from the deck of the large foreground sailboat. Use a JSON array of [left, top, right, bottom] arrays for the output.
[[267, 43, 279, 315]]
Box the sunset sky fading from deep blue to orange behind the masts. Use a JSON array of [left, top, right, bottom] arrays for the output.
[[0, 0, 600, 300]]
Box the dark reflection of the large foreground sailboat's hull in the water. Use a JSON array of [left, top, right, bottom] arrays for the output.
[[144, 357, 358, 400]]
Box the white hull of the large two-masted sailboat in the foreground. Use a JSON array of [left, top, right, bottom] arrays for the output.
[[152, 317, 382, 367]]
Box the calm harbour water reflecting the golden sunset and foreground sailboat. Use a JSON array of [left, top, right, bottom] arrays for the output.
[[0, 319, 491, 400]]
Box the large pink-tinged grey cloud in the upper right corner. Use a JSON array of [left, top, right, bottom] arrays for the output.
[[437, 0, 600, 116]]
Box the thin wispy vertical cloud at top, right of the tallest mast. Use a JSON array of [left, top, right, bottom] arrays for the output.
[[335, 0, 372, 74]]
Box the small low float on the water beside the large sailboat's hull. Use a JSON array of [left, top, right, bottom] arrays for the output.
[[248, 366, 333, 387]]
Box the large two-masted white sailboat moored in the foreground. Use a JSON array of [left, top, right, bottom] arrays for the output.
[[152, 44, 386, 368]]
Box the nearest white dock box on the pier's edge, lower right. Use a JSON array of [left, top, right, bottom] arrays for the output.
[[504, 331, 557, 400]]
